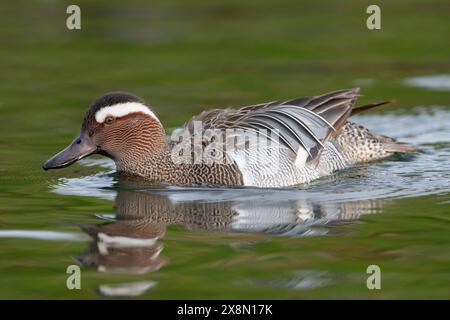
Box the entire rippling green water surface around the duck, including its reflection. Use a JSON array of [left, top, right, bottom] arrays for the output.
[[0, 1, 450, 299]]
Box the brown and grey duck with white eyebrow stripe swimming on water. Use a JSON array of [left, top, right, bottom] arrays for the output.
[[43, 88, 416, 188]]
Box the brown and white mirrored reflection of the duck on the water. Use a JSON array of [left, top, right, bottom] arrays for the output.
[[77, 189, 382, 296]]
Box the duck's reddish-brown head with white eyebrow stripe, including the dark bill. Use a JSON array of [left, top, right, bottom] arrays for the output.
[[43, 92, 165, 170]]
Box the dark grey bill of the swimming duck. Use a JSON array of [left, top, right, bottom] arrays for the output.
[[42, 134, 97, 170]]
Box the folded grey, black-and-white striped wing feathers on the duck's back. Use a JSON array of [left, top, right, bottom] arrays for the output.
[[184, 88, 359, 160]]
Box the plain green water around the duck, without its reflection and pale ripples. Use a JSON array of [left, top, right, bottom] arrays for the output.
[[0, 0, 450, 299]]
